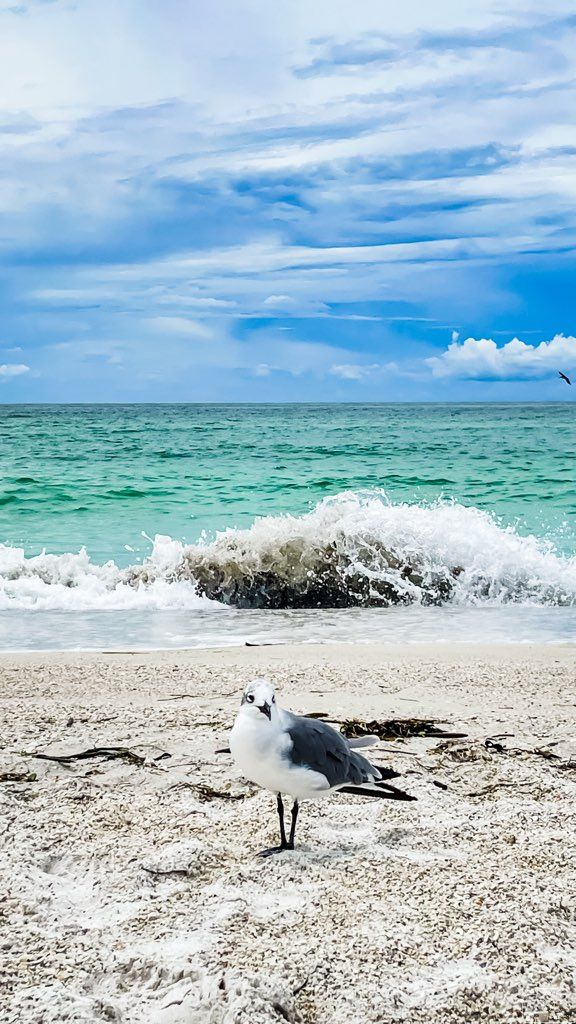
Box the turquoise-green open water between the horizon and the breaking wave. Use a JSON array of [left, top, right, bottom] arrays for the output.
[[0, 403, 576, 565]]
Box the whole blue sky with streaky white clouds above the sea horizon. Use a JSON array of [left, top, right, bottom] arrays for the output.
[[0, 0, 576, 402]]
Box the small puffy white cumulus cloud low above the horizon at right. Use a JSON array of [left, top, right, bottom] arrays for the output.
[[425, 334, 576, 380]]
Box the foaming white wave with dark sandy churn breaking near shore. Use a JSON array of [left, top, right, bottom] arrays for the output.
[[0, 492, 576, 610]]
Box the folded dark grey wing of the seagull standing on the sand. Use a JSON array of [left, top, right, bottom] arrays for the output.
[[284, 712, 381, 787]]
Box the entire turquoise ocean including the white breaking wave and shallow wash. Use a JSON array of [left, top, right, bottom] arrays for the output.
[[0, 402, 576, 649]]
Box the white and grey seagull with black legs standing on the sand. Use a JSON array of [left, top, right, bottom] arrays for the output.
[[230, 679, 416, 857]]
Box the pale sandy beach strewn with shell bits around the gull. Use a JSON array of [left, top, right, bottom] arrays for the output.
[[0, 645, 576, 1024]]
